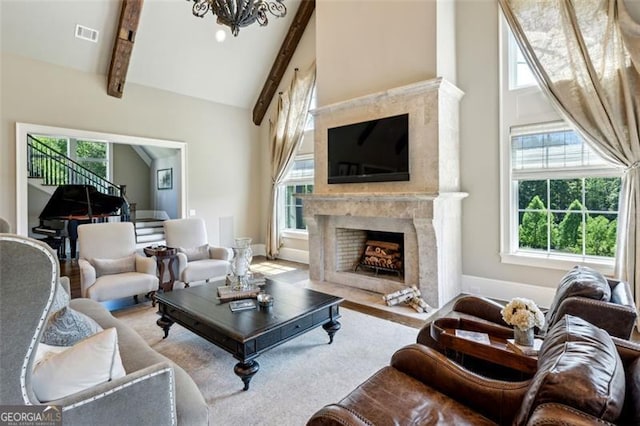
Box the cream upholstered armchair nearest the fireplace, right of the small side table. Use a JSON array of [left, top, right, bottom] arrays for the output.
[[164, 218, 233, 287]]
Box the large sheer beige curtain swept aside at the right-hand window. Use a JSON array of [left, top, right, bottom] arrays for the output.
[[499, 0, 640, 320]]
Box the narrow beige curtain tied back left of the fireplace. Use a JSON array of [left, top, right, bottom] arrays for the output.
[[266, 63, 316, 259]]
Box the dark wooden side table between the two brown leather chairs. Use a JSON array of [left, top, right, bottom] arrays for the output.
[[431, 317, 538, 374]]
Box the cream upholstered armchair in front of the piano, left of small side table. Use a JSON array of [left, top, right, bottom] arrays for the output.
[[78, 222, 159, 302]]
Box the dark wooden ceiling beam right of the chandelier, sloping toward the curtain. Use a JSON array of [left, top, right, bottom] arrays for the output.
[[253, 0, 316, 126]]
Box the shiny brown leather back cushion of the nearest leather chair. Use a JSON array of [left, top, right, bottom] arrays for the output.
[[514, 315, 626, 425]]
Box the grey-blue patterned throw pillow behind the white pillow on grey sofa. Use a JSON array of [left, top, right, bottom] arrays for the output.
[[40, 306, 102, 346]]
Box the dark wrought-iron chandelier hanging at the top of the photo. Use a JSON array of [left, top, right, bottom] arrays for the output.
[[187, 0, 287, 36]]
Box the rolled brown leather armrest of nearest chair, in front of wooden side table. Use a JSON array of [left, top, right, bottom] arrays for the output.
[[391, 344, 531, 424]]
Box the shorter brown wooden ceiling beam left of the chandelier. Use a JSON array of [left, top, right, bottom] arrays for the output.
[[107, 0, 143, 98]]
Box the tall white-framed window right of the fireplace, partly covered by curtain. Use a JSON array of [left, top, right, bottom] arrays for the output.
[[501, 20, 621, 272]]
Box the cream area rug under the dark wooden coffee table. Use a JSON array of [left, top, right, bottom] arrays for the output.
[[114, 305, 418, 426]]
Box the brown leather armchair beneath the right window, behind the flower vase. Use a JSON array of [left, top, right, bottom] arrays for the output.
[[417, 266, 638, 349]]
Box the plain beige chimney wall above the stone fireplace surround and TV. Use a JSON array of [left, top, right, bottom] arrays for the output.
[[316, 0, 437, 106]]
